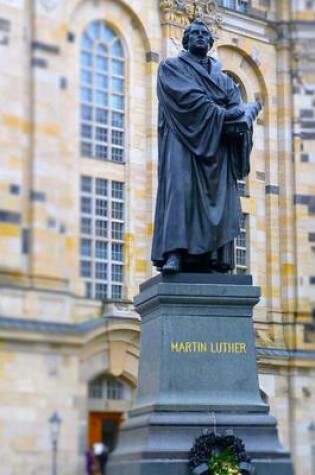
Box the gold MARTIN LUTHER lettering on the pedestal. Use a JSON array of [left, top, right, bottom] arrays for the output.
[[170, 341, 247, 354]]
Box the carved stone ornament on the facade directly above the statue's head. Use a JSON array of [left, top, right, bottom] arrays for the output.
[[160, 0, 223, 31]]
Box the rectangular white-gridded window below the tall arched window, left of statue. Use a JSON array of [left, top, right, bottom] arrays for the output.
[[79, 175, 126, 300]]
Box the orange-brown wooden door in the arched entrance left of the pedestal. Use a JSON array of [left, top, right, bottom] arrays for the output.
[[88, 412, 122, 451]]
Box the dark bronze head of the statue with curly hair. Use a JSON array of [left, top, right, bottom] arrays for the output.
[[182, 18, 214, 55]]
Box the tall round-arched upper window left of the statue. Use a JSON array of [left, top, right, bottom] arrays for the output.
[[80, 21, 125, 163]]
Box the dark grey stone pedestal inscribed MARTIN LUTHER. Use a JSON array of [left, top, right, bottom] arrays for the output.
[[107, 274, 293, 475]]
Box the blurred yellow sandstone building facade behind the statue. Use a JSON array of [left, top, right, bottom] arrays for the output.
[[0, 0, 315, 475]]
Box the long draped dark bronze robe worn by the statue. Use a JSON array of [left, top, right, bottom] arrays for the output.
[[152, 52, 251, 268]]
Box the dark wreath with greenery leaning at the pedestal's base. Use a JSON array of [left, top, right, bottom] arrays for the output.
[[189, 432, 255, 475]]
